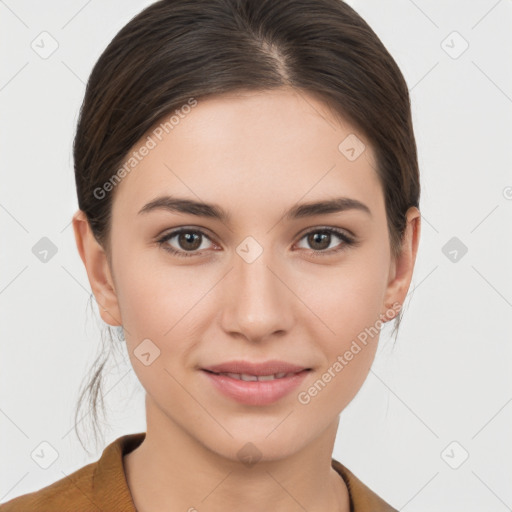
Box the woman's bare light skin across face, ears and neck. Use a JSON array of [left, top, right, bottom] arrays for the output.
[[73, 89, 420, 512]]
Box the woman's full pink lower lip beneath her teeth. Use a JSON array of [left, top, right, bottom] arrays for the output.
[[202, 370, 309, 405]]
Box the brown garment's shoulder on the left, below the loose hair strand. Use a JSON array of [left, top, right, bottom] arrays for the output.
[[0, 433, 145, 512]]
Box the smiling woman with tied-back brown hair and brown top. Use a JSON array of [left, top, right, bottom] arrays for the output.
[[0, 0, 420, 512]]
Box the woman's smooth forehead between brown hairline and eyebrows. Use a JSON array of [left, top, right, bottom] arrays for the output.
[[114, 89, 382, 222]]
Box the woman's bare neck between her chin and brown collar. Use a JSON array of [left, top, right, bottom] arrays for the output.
[[124, 401, 350, 512]]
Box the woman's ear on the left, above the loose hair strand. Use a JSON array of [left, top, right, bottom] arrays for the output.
[[73, 210, 122, 326]]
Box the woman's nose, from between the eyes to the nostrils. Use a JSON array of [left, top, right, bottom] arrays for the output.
[[218, 245, 299, 342]]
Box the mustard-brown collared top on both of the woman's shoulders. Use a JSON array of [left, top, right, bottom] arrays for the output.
[[0, 432, 397, 512]]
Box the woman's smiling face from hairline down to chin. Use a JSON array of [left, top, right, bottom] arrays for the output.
[[79, 89, 416, 460]]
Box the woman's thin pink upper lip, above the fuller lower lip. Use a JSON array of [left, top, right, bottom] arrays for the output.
[[203, 359, 311, 381]]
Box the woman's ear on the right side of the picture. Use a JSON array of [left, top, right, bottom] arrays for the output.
[[382, 206, 421, 321]]
